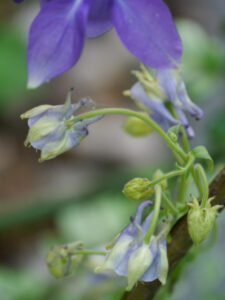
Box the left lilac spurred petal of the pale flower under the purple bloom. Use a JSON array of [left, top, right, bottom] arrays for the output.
[[130, 82, 178, 125]]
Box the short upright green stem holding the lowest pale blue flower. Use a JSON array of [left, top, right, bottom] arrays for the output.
[[144, 185, 162, 244]]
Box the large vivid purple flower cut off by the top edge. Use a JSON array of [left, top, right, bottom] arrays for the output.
[[17, 0, 182, 88]]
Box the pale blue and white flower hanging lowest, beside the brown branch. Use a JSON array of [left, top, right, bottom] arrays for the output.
[[96, 201, 168, 290]]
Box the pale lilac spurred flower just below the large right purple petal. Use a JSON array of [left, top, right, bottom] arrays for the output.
[[125, 66, 203, 138]]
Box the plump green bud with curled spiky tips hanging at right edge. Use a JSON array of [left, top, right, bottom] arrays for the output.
[[187, 198, 223, 244]]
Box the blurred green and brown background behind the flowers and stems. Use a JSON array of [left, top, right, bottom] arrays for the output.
[[0, 0, 225, 300]]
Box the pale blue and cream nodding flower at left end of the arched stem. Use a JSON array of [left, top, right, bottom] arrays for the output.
[[21, 92, 102, 162]]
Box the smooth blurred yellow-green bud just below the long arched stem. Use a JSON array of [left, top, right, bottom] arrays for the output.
[[123, 117, 153, 137]]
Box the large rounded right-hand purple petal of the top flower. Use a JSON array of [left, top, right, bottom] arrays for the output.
[[112, 0, 182, 69]]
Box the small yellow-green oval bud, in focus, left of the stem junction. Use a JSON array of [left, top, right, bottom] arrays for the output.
[[123, 178, 154, 201]]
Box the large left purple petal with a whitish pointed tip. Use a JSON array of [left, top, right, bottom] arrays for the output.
[[28, 0, 89, 88]]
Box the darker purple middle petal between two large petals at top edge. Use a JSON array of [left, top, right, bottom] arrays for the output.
[[86, 0, 113, 38]]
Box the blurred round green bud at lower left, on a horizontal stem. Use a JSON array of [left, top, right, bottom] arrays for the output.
[[45, 242, 83, 278]]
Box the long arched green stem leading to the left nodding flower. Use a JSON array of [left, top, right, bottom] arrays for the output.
[[65, 108, 187, 161]]
